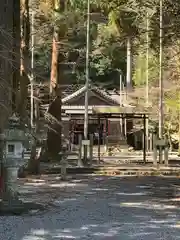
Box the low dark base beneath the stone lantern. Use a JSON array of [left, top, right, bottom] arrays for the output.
[[0, 200, 44, 215]]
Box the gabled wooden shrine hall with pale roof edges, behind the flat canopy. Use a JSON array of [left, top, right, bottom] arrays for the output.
[[62, 86, 133, 144]]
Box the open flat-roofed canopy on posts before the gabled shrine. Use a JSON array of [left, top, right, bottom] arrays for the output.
[[65, 107, 148, 163]]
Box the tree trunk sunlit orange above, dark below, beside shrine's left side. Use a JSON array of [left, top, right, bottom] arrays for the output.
[[47, 0, 66, 156]]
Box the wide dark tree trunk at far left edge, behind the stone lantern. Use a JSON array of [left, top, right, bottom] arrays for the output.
[[0, 0, 15, 199]]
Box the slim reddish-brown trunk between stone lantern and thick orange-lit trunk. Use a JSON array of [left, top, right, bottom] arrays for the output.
[[19, 0, 39, 174]]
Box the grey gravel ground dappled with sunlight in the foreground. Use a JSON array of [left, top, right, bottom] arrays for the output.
[[0, 176, 180, 240]]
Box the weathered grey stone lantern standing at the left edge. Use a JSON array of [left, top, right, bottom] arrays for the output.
[[0, 116, 27, 211]]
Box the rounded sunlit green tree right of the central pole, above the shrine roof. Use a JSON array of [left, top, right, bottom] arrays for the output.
[[91, 25, 126, 88]]
